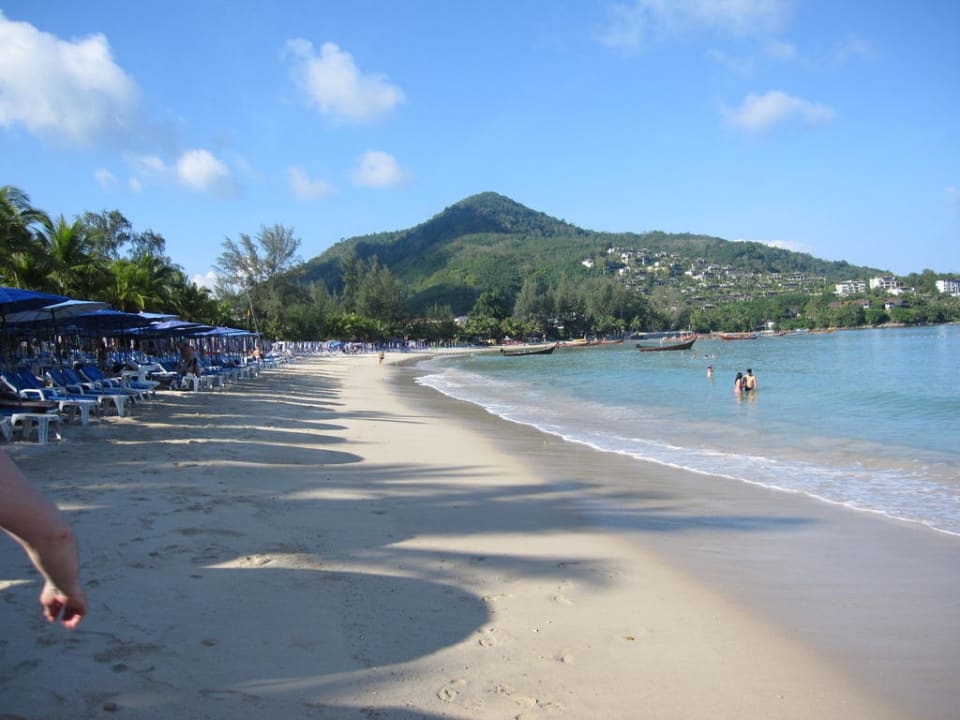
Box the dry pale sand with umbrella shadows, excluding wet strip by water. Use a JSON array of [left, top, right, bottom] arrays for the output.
[[0, 356, 928, 720]]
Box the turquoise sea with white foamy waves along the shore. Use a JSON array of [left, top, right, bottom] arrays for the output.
[[418, 325, 960, 535]]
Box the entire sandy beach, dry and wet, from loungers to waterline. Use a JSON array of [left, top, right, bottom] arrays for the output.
[[0, 356, 960, 720]]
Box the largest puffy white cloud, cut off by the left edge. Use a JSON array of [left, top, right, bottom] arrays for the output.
[[0, 12, 139, 145]]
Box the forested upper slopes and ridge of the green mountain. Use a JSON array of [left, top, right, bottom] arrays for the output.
[[301, 192, 882, 314]]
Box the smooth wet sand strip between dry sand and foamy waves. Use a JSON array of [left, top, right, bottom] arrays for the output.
[[394, 352, 960, 718]]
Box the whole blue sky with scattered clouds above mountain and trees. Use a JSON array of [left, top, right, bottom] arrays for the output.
[[0, 0, 960, 286]]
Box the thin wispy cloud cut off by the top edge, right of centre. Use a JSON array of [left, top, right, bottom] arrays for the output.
[[598, 0, 792, 51]]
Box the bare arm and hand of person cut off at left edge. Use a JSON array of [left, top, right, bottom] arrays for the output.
[[0, 450, 87, 629]]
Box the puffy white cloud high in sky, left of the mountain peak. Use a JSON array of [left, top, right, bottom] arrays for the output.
[[284, 38, 404, 122]]
